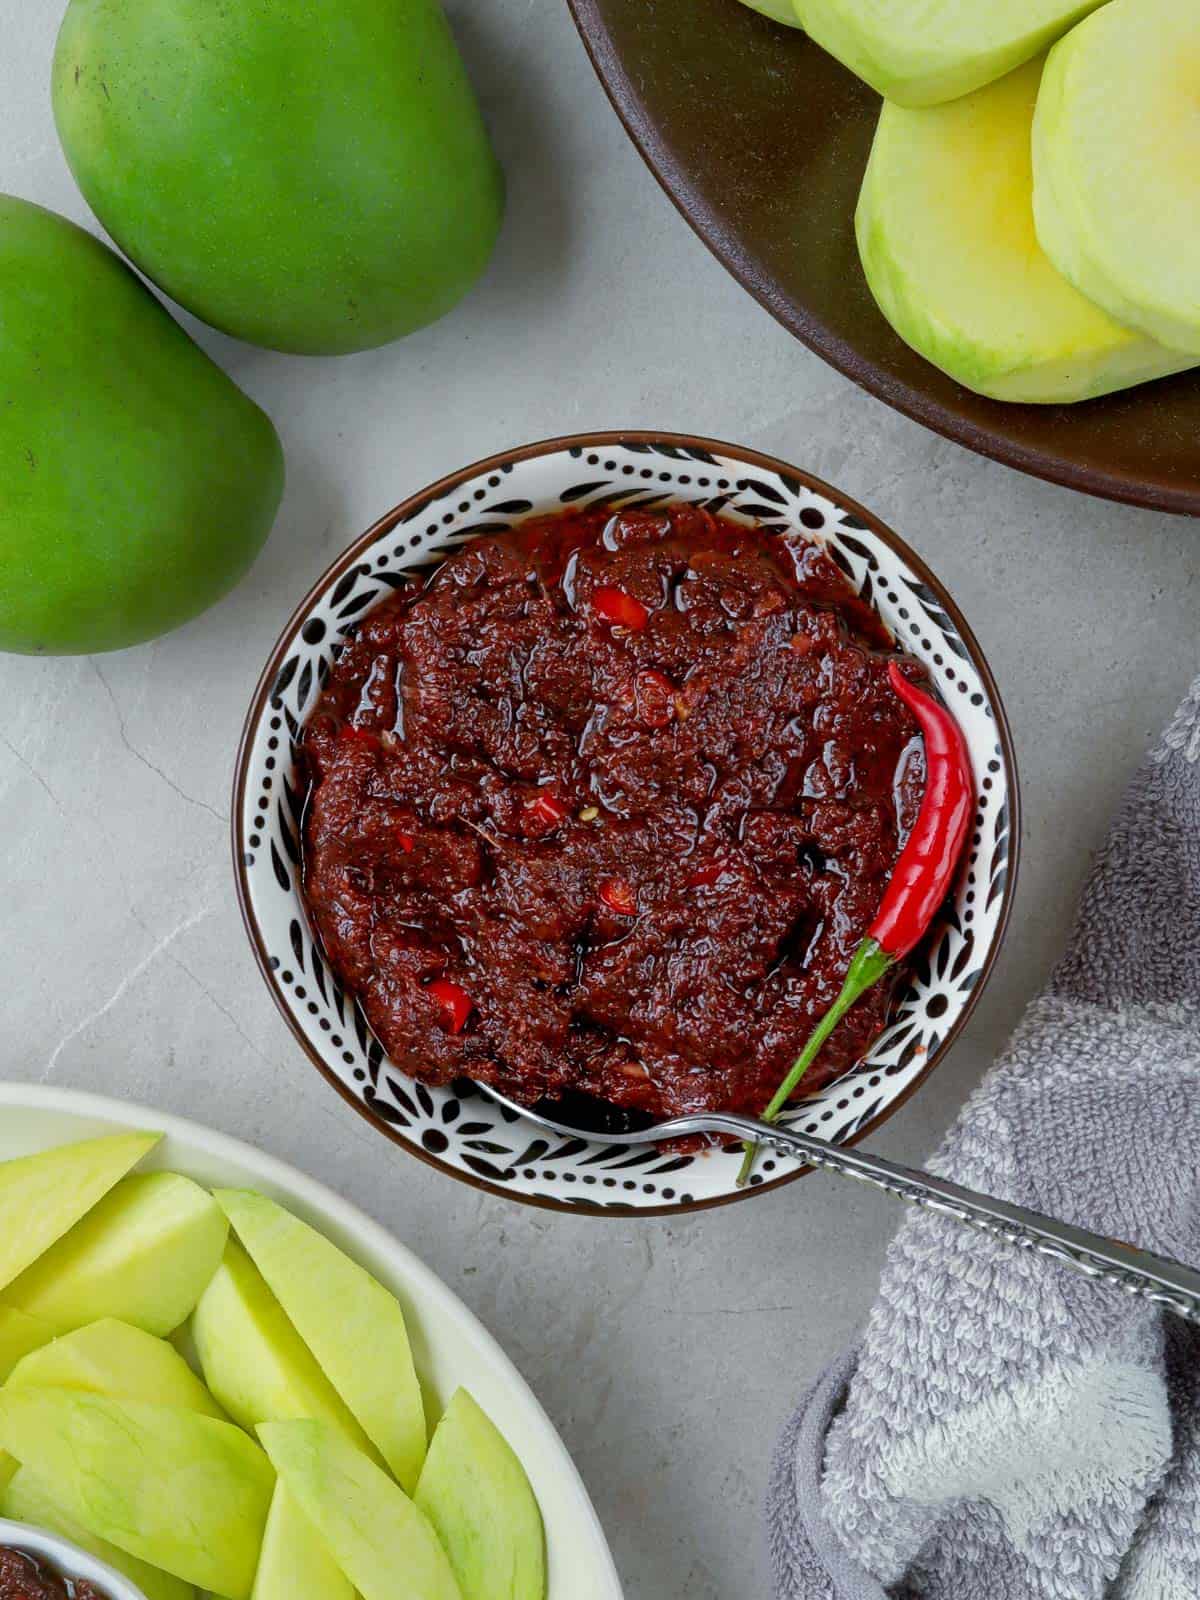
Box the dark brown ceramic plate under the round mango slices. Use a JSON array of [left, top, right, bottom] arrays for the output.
[[570, 0, 1200, 515]]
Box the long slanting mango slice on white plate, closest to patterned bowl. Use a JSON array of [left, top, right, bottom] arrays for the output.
[[216, 1189, 426, 1494]]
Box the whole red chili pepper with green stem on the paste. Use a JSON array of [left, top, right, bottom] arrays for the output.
[[738, 661, 974, 1187]]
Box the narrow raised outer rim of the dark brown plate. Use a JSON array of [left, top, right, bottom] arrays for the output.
[[566, 0, 1200, 517]]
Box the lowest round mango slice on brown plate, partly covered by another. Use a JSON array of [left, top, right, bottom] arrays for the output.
[[856, 56, 1197, 405]]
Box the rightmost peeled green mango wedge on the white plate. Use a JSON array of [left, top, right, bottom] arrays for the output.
[[414, 1389, 546, 1600]]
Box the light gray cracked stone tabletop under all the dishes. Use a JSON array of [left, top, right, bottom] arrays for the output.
[[0, 0, 1200, 1600]]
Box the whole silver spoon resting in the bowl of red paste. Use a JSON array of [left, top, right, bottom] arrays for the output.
[[478, 1083, 1200, 1322]]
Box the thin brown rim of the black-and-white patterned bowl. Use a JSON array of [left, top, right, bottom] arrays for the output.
[[230, 429, 1021, 1219]]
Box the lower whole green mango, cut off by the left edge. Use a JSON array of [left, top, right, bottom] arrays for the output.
[[0, 195, 283, 654]]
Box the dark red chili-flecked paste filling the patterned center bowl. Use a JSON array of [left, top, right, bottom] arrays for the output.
[[304, 506, 923, 1117]]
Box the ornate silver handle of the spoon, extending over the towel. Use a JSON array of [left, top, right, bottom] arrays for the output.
[[698, 1112, 1200, 1322]]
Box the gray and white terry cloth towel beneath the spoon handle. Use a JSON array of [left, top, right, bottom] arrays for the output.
[[768, 680, 1200, 1600]]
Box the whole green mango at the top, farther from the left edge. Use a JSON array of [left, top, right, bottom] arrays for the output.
[[53, 0, 504, 355]]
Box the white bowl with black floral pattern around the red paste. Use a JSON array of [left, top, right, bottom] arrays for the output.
[[234, 432, 1019, 1214]]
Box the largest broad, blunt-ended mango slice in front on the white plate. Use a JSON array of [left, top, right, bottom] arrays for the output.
[[0, 1387, 275, 1600]]
